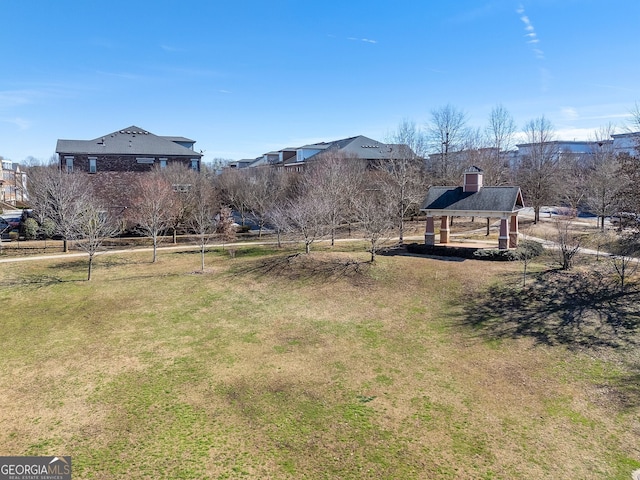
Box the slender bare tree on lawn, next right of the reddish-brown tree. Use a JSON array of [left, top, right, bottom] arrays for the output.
[[187, 175, 219, 271]]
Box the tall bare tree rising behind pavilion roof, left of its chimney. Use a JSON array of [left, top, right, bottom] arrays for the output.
[[427, 104, 467, 184]]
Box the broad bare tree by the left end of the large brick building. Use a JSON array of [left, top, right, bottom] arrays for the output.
[[28, 166, 90, 252]]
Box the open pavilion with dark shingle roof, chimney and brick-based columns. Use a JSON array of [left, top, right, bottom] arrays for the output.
[[420, 167, 524, 250]]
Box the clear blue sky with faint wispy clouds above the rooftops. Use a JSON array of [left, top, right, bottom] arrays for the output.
[[0, 0, 640, 162]]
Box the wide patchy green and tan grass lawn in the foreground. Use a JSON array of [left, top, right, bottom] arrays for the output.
[[0, 247, 640, 479]]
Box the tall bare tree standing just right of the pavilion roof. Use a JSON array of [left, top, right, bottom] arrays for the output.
[[517, 117, 559, 223]]
